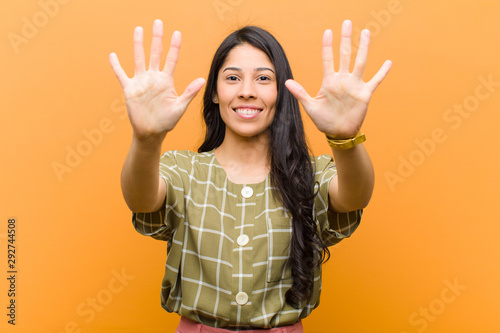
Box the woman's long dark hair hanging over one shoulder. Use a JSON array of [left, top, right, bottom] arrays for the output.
[[198, 26, 330, 307]]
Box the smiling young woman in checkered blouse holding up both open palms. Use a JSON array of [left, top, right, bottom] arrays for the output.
[[110, 20, 391, 332]]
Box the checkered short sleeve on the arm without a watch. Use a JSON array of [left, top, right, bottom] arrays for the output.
[[132, 151, 187, 241]]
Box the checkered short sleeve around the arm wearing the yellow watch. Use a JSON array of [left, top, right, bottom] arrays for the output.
[[313, 155, 363, 246]]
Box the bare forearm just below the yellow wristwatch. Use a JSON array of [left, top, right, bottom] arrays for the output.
[[329, 144, 375, 212]]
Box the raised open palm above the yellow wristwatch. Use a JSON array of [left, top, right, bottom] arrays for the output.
[[285, 20, 392, 139]]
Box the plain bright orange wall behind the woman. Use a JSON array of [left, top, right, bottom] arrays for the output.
[[0, 0, 500, 333]]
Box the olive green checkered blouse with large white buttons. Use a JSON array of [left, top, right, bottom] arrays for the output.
[[132, 151, 362, 330]]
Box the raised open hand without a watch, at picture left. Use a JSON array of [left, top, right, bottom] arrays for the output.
[[109, 20, 205, 141]]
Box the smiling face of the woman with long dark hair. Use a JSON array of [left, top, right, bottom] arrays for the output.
[[215, 43, 278, 138]]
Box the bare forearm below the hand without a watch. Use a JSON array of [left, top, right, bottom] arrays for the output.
[[121, 136, 166, 212]]
